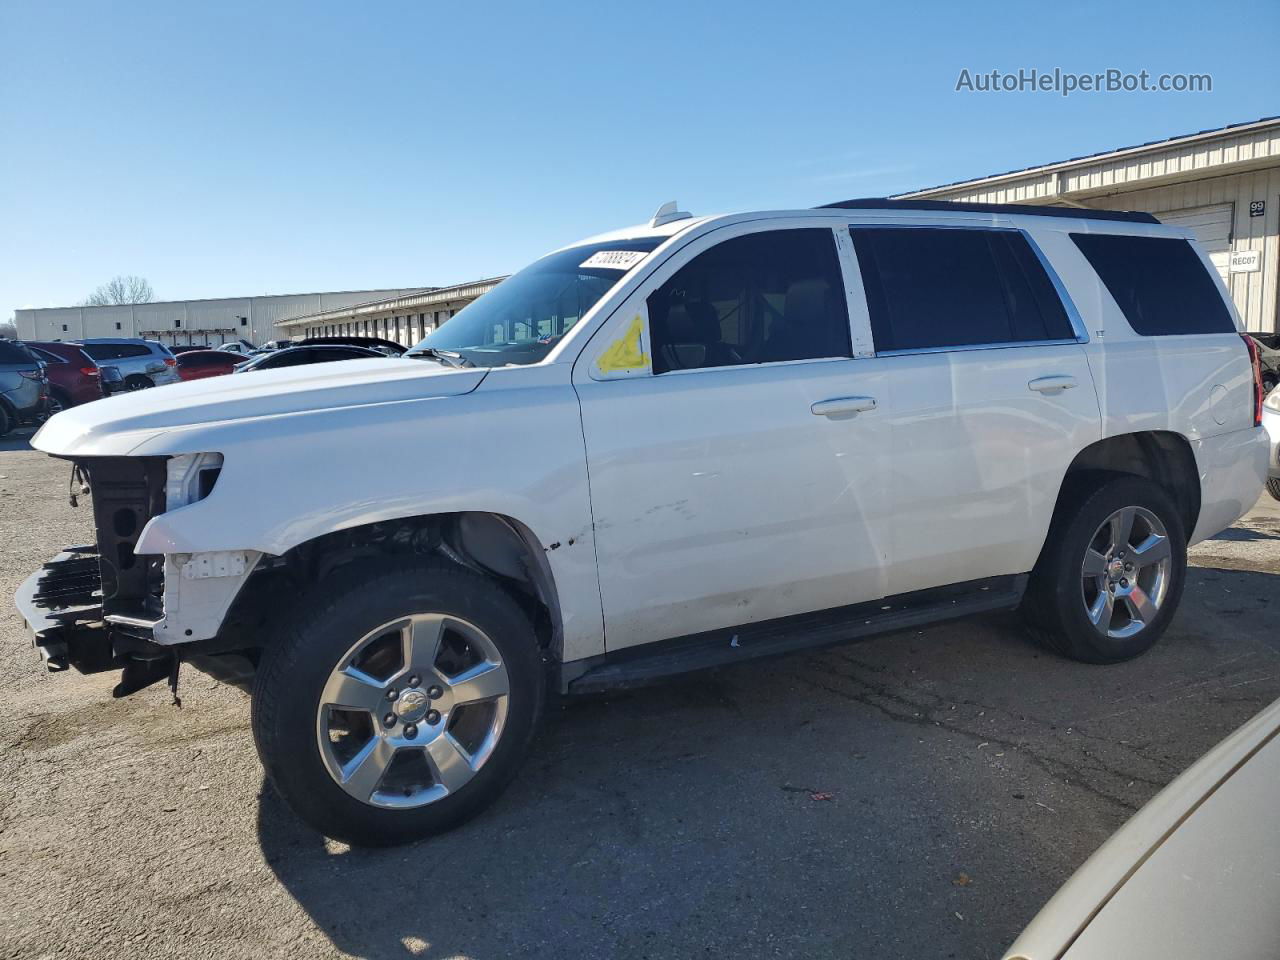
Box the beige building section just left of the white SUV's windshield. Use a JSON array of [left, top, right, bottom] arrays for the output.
[[276, 276, 506, 347]]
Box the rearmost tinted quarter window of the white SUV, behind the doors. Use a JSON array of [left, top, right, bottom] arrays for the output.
[[1071, 233, 1235, 337]]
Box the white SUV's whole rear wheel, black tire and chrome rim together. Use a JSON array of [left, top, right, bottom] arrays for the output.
[[1021, 476, 1187, 663]]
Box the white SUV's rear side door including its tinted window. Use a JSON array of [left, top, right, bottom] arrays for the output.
[[851, 224, 1101, 595]]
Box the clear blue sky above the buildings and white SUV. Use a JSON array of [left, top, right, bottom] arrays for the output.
[[0, 0, 1280, 319]]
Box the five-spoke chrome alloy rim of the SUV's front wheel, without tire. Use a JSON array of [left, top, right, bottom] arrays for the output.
[[316, 613, 511, 809]]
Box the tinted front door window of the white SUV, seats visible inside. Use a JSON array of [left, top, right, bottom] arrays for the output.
[[648, 228, 852, 374]]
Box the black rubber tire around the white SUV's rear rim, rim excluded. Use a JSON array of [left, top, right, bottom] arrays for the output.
[[1021, 476, 1187, 663]]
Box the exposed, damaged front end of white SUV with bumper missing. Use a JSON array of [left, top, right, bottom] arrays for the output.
[[14, 457, 260, 696]]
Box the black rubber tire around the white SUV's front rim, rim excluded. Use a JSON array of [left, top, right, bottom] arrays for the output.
[[252, 561, 547, 846]]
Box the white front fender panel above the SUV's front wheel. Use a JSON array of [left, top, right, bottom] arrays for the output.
[[133, 366, 604, 659]]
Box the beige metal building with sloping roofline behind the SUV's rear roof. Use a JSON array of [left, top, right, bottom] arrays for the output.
[[900, 116, 1280, 333]]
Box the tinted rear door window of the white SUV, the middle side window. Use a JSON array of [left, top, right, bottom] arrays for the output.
[[850, 227, 1075, 352]]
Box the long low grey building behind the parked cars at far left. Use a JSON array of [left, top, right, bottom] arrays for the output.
[[14, 287, 424, 347]]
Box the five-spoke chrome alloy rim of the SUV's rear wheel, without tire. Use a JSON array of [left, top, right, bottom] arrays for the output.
[[1080, 507, 1172, 640]]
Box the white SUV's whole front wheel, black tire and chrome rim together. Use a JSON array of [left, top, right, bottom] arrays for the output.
[[252, 561, 547, 846]]
